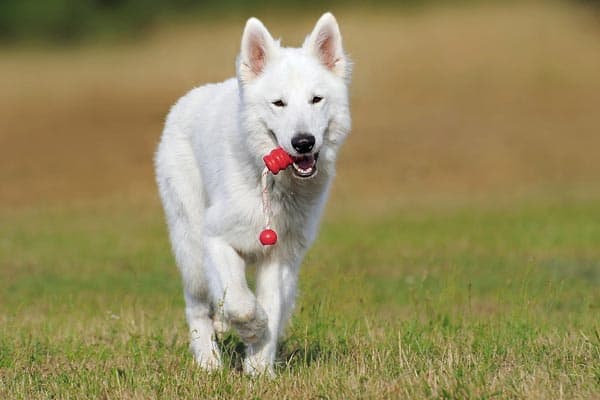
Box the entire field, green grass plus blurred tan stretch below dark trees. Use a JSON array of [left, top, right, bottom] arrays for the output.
[[0, 2, 600, 399]]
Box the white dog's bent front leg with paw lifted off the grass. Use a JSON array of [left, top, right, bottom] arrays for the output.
[[204, 237, 267, 343]]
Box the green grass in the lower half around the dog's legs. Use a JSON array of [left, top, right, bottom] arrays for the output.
[[0, 200, 600, 399]]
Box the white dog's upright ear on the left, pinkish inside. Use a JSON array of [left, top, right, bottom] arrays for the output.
[[238, 17, 278, 83]]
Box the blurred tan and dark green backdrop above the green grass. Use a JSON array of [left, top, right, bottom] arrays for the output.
[[0, 0, 600, 213]]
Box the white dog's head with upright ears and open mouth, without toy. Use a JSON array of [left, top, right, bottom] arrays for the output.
[[237, 13, 351, 178]]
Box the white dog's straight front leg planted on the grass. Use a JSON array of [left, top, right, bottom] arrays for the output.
[[244, 258, 297, 376]]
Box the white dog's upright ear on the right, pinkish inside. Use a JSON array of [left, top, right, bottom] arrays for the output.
[[303, 12, 350, 79]]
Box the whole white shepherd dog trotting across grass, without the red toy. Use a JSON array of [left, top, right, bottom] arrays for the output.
[[155, 13, 350, 375]]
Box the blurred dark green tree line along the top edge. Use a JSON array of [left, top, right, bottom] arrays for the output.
[[0, 0, 600, 43]]
